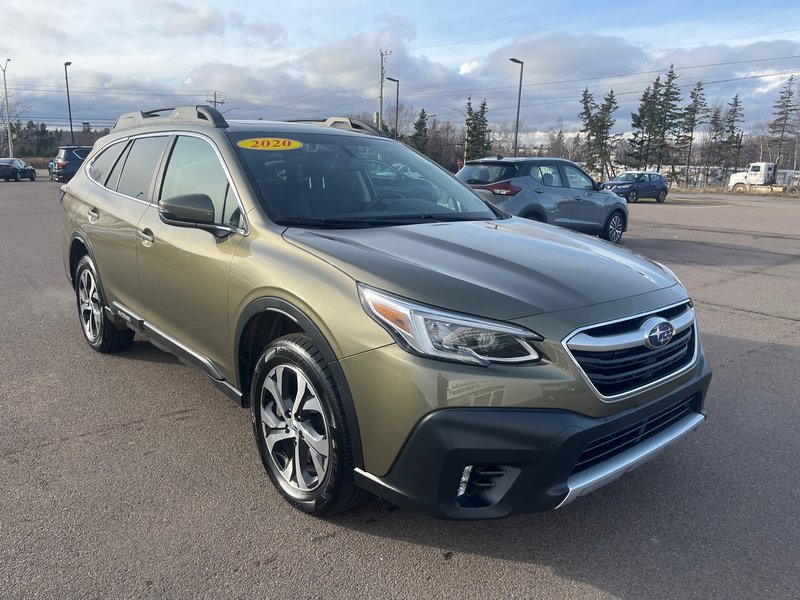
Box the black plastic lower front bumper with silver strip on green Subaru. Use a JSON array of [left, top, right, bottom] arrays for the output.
[[356, 353, 711, 519]]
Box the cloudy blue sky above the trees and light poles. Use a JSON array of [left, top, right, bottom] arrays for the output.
[[0, 0, 800, 132]]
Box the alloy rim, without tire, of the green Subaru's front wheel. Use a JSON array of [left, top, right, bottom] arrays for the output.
[[259, 364, 331, 494]]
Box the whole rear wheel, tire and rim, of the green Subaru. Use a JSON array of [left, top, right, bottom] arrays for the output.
[[74, 255, 135, 353]]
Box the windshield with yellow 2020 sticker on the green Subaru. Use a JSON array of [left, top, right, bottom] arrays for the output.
[[229, 130, 498, 227]]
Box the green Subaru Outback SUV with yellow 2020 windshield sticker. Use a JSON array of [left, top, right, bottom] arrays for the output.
[[61, 106, 711, 519]]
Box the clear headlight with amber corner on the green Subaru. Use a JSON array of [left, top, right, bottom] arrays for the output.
[[358, 284, 543, 366]]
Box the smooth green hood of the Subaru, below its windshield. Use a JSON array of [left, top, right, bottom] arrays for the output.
[[284, 219, 676, 320]]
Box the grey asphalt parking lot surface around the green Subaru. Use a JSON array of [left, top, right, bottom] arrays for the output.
[[0, 177, 800, 599]]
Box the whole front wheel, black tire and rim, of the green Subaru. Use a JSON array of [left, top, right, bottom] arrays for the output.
[[250, 334, 369, 516]]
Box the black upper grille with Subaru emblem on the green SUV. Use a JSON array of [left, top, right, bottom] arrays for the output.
[[567, 304, 697, 397]]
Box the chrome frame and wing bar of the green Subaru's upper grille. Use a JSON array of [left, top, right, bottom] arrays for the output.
[[561, 300, 700, 403]]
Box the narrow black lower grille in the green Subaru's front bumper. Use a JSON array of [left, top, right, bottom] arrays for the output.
[[572, 395, 699, 475]]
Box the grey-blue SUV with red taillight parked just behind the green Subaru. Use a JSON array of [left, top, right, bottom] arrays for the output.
[[456, 157, 628, 244]]
